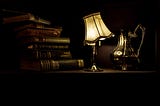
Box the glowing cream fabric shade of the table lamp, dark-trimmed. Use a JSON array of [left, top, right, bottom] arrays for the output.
[[83, 12, 113, 43]]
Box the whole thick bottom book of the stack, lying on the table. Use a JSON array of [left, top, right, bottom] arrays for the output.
[[19, 59, 84, 72]]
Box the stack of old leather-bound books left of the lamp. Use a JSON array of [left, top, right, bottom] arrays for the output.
[[3, 9, 84, 71]]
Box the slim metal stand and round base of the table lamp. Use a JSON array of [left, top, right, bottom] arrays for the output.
[[85, 43, 103, 72]]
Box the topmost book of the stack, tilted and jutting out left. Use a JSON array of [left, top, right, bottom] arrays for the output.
[[2, 13, 51, 25]]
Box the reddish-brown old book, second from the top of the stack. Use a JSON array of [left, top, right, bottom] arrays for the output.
[[16, 28, 62, 39]]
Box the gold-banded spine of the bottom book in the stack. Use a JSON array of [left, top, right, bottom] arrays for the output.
[[40, 59, 84, 71]]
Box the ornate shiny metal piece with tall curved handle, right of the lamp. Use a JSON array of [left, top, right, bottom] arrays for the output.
[[111, 24, 145, 70]]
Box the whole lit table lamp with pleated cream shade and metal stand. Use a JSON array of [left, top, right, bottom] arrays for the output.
[[83, 12, 114, 72]]
